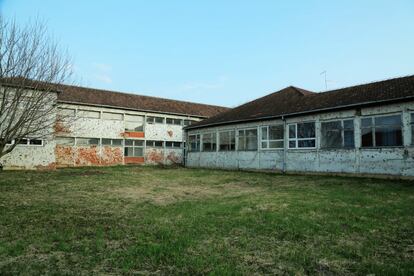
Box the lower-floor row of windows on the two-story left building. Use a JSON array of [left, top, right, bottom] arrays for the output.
[[56, 137, 183, 148]]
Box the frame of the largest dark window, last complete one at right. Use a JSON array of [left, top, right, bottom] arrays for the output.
[[360, 112, 404, 149]]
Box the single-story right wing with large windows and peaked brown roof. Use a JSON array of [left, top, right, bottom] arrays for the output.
[[185, 76, 414, 177]]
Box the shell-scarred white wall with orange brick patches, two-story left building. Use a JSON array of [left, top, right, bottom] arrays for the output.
[[0, 104, 201, 169]]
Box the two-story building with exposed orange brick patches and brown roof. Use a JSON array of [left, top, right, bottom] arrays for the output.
[[0, 81, 226, 169]]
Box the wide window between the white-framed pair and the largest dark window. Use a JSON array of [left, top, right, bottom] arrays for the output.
[[321, 120, 355, 148]]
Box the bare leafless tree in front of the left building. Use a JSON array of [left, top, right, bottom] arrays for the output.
[[0, 16, 72, 164]]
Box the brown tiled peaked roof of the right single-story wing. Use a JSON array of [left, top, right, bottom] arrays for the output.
[[187, 76, 414, 129]]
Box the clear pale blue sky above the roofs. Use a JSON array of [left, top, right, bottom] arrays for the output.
[[0, 0, 414, 107]]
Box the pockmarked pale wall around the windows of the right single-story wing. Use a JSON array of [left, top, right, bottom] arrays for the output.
[[186, 102, 414, 176]]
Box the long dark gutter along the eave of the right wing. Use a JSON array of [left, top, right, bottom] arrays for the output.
[[184, 96, 414, 130]]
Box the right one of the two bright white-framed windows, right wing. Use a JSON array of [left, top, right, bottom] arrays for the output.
[[289, 122, 316, 148]]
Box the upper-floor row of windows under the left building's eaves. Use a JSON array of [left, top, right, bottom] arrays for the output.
[[58, 108, 197, 126]]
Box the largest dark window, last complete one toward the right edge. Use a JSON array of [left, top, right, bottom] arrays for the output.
[[361, 115, 403, 147]]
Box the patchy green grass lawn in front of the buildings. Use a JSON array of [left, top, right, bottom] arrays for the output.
[[0, 167, 414, 275]]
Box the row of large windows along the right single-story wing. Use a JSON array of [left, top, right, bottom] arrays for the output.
[[188, 113, 414, 151]]
